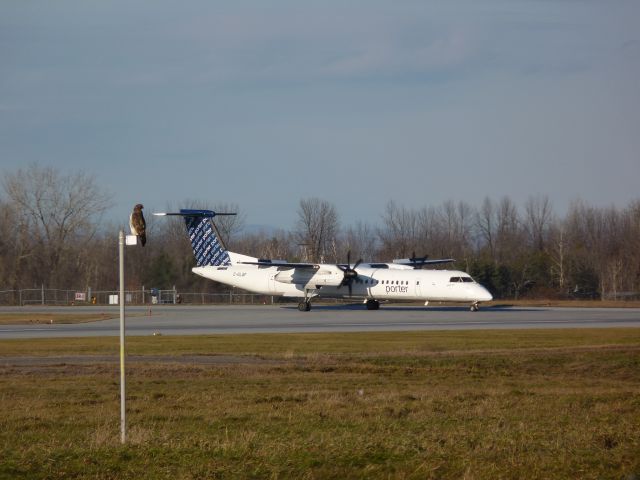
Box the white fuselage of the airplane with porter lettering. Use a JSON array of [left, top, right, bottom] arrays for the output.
[[193, 264, 492, 303]]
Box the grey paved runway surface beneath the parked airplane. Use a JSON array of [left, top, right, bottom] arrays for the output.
[[0, 305, 640, 340]]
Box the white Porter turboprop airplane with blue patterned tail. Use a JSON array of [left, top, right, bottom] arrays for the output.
[[154, 209, 493, 312]]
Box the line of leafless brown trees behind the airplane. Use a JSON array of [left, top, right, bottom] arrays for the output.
[[0, 165, 640, 299]]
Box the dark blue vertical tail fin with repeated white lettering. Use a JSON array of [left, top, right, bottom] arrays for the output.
[[180, 209, 231, 267]]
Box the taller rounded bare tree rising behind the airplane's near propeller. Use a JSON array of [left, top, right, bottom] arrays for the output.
[[296, 198, 339, 262]]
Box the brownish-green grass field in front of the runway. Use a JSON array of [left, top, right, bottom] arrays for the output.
[[0, 329, 640, 479]]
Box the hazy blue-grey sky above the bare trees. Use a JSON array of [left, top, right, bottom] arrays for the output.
[[0, 0, 640, 229]]
